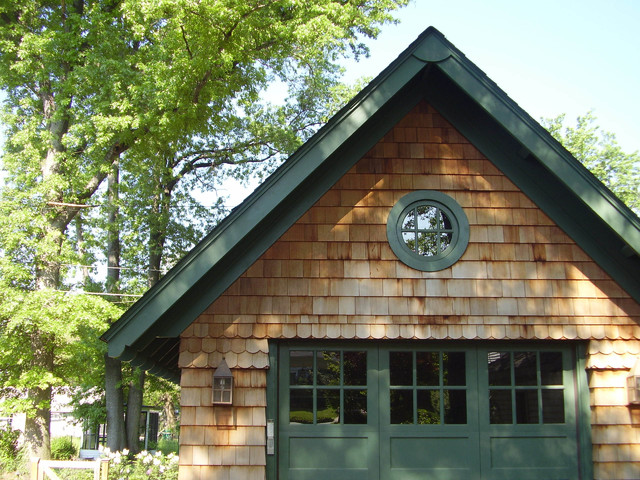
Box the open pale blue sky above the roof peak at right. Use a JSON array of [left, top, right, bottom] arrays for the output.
[[346, 0, 640, 153]]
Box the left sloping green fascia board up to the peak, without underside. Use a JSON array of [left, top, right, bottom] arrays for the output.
[[102, 28, 446, 357]]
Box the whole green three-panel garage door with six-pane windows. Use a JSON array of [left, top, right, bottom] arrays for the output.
[[277, 343, 579, 480]]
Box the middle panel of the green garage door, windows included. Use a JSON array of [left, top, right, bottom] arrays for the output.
[[379, 344, 480, 480]]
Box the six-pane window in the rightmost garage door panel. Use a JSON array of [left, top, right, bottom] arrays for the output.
[[487, 351, 565, 424]]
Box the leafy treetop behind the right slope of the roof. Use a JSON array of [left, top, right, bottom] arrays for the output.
[[542, 111, 640, 214]]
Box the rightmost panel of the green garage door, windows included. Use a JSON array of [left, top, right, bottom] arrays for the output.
[[478, 346, 578, 480]]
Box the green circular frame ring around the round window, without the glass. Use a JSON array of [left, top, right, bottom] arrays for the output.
[[387, 190, 469, 272]]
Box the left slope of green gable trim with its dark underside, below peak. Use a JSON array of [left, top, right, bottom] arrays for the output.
[[102, 58, 424, 366]]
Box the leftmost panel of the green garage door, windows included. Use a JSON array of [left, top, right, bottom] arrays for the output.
[[278, 345, 379, 480]]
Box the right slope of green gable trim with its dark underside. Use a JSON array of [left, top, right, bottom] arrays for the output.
[[425, 56, 640, 302]]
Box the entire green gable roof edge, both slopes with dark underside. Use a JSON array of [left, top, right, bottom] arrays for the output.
[[102, 27, 640, 381]]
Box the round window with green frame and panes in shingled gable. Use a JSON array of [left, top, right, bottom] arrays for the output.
[[387, 190, 469, 272]]
